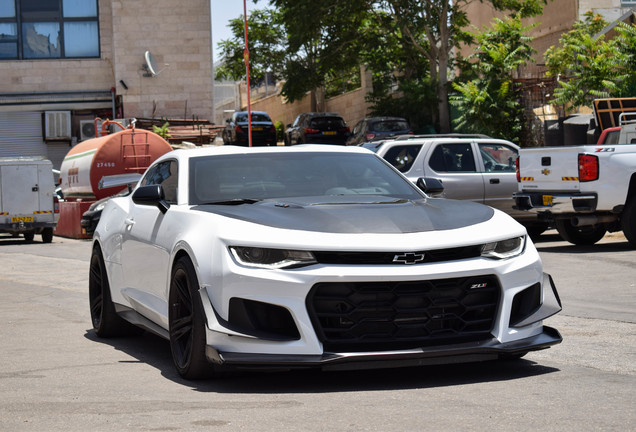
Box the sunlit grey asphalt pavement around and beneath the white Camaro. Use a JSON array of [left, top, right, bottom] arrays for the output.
[[0, 233, 636, 432]]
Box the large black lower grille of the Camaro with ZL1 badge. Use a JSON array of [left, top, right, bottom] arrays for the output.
[[307, 275, 501, 352]]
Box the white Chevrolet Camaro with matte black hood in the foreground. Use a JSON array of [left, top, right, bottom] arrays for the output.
[[89, 145, 561, 379]]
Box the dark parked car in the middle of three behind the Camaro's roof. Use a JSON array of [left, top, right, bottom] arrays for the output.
[[285, 112, 351, 145]]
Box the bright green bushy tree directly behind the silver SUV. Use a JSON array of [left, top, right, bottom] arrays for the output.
[[450, 16, 535, 143]]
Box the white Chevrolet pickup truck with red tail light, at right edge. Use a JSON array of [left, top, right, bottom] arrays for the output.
[[513, 119, 636, 247]]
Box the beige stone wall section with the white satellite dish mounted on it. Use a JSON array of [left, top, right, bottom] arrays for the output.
[[112, 0, 213, 121]]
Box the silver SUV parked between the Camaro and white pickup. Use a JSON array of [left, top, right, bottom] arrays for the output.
[[361, 134, 548, 236]]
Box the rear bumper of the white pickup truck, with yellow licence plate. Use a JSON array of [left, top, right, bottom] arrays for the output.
[[512, 191, 598, 214]]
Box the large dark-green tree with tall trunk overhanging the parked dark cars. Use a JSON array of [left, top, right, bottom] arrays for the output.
[[219, 0, 548, 132]]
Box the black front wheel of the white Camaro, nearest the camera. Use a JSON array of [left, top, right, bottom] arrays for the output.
[[168, 257, 214, 380]]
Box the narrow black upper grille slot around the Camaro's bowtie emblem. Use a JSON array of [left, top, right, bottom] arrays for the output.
[[313, 245, 481, 265]]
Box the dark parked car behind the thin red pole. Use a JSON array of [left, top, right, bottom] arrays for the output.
[[221, 111, 276, 146]]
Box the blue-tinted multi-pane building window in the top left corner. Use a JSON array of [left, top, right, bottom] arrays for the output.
[[0, 0, 99, 60]]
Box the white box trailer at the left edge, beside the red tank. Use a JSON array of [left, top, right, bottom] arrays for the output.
[[0, 157, 59, 243]]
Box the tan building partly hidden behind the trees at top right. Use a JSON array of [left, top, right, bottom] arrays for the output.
[[461, 0, 636, 78]]
